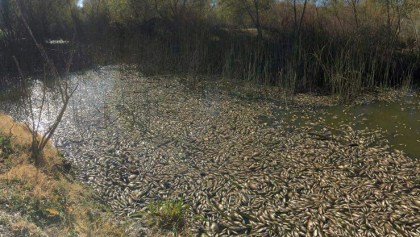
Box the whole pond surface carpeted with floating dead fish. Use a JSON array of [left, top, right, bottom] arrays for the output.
[[0, 67, 420, 236]]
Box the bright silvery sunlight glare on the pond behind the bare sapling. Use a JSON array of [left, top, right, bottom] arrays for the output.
[[0, 69, 115, 138]]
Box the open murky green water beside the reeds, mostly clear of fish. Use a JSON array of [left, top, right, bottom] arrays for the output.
[[266, 93, 420, 158]]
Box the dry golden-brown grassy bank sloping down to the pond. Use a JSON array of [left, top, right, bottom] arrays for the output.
[[0, 114, 138, 236]]
